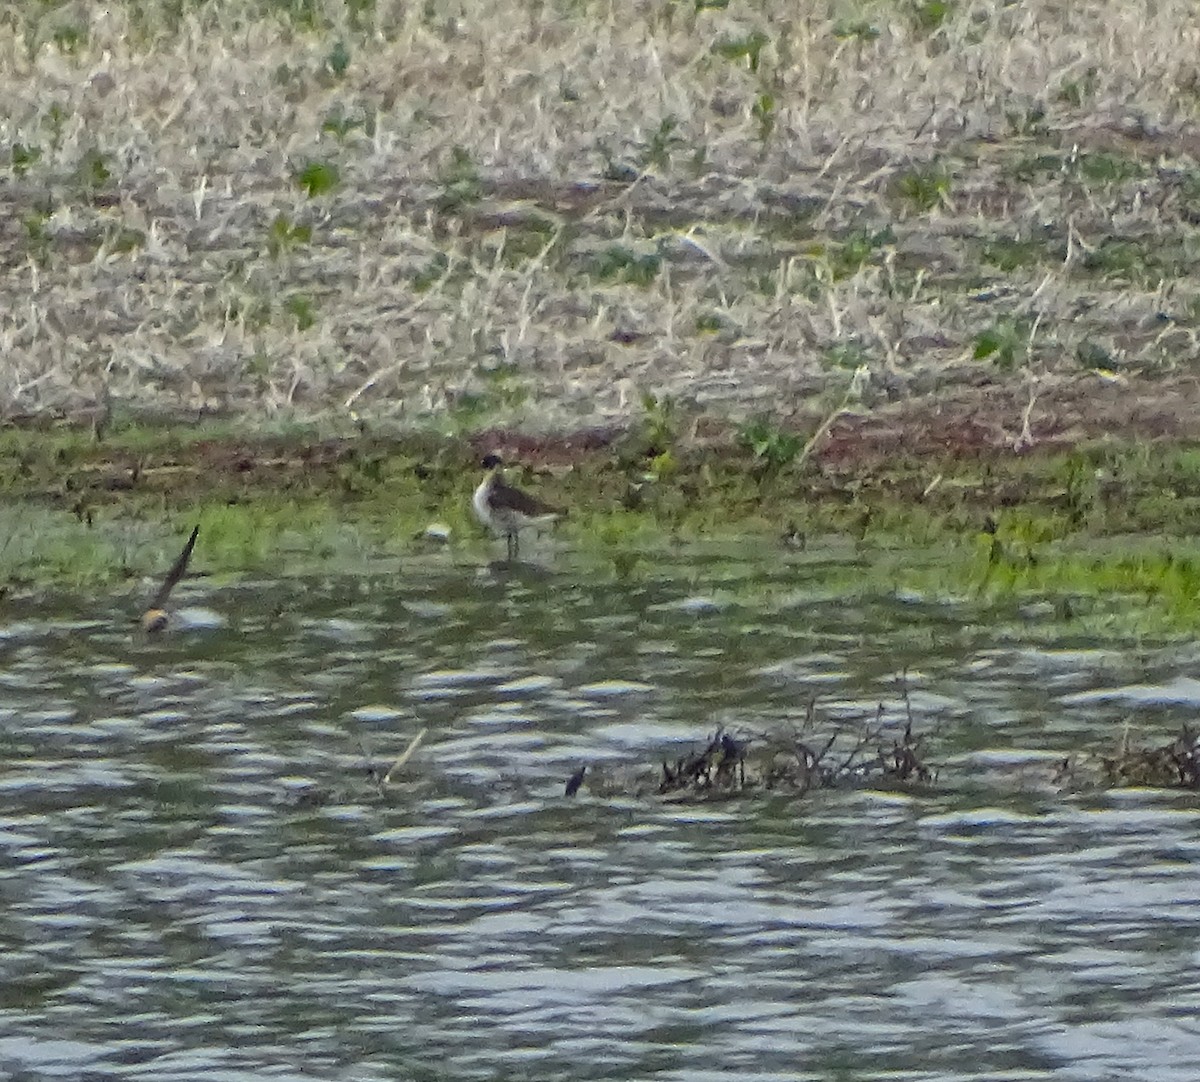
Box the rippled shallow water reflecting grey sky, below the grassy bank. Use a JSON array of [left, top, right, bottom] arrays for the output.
[[0, 552, 1200, 1082]]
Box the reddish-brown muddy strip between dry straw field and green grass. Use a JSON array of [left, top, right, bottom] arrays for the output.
[[9, 364, 1200, 506]]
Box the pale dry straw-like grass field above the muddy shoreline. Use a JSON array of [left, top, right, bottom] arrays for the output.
[[7, 0, 1200, 431]]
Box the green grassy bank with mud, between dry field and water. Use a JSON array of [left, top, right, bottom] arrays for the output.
[[7, 414, 1200, 636]]
